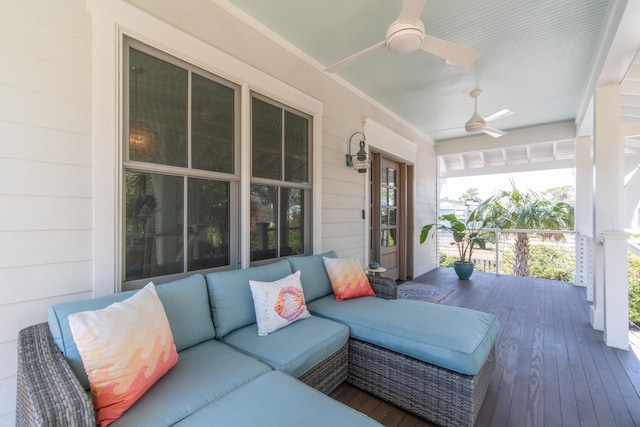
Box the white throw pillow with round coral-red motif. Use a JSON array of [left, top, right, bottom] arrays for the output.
[[249, 271, 311, 336]]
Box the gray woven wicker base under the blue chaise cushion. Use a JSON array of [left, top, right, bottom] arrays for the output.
[[347, 339, 495, 426]]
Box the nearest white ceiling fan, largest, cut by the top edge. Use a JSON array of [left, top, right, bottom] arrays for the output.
[[325, 0, 482, 73]]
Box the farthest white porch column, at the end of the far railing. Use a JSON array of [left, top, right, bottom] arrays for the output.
[[573, 136, 593, 294]]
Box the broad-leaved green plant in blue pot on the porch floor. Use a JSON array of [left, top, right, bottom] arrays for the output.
[[420, 210, 487, 280]]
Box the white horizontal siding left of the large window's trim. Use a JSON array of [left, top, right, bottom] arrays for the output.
[[0, 0, 93, 425]]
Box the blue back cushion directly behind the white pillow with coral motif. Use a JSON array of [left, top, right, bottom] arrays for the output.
[[206, 259, 292, 338]]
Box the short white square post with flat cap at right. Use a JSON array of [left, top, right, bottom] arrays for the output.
[[602, 230, 630, 350]]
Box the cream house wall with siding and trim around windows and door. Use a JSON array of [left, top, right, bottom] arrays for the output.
[[0, 0, 636, 425]]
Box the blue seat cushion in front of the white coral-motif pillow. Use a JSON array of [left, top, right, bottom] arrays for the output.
[[223, 316, 349, 378]]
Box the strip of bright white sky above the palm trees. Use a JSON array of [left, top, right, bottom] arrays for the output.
[[440, 168, 575, 200]]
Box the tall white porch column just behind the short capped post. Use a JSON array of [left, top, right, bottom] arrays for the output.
[[590, 84, 627, 331]]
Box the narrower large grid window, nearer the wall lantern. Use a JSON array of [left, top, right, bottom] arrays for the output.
[[250, 94, 311, 261]]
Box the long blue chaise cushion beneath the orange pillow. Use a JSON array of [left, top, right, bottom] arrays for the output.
[[308, 295, 499, 375]]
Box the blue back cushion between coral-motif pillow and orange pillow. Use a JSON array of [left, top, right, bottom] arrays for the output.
[[287, 251, 337, 302]]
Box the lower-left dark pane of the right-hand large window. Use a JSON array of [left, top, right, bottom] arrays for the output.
[[251, 185, 278, 261]]
